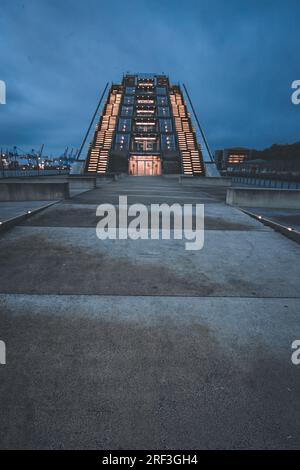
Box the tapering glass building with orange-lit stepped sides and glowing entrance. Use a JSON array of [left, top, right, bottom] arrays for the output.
[[85, 74, 204, 176]]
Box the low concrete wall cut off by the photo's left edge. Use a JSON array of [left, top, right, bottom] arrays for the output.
[[0, 181, 69, 201]]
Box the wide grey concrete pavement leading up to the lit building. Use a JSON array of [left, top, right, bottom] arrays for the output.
[[0, 177, 300, 450]]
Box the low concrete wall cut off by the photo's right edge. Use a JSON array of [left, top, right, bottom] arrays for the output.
[[226, 188, 300, 209]]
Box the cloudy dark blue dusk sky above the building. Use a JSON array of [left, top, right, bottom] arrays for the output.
[[0, 0, 300, 155]]
